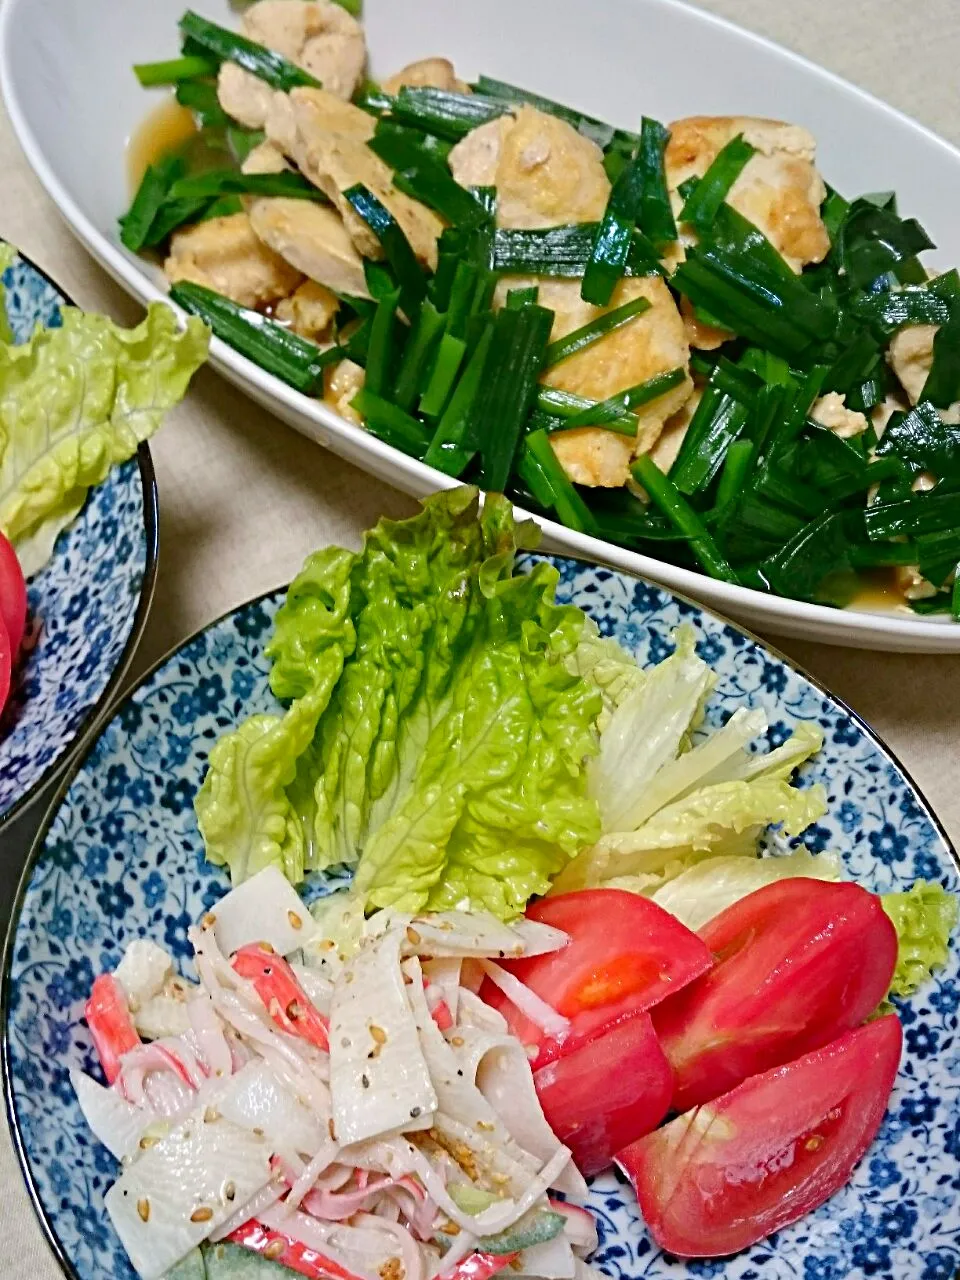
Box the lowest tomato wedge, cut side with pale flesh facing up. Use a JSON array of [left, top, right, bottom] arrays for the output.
[[617, 1014, 902, 1258]]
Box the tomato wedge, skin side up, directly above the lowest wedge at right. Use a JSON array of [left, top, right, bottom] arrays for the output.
[[653, 879, 897, 1111]]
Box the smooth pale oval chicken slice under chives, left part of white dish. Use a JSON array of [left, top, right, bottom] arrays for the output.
[[248, 196, 370, 298]]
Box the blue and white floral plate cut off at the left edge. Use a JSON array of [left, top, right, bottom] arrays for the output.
[[0, 250, 157, 828]]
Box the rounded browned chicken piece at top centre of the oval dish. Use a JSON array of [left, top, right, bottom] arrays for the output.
[[449, 106, 611, 228]]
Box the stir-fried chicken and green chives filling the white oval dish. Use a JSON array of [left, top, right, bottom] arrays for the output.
[[128, 0, 960, 617]]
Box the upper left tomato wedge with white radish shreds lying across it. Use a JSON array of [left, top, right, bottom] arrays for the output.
[[481, 888, 713, 1070]]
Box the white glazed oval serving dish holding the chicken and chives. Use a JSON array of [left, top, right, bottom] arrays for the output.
[[0, 0, 960, 653]]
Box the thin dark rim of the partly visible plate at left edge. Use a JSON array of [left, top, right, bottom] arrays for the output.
[[0, 244, 160, 836]]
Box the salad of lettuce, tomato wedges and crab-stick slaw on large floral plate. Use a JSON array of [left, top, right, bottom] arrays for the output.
[[72, 488, 956, 1280]]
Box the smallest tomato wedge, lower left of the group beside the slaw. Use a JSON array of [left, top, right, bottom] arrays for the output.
[[534, 1014, 673, 1178]]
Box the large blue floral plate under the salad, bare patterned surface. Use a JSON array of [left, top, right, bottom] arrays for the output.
[[3, 559, 960, 1280]]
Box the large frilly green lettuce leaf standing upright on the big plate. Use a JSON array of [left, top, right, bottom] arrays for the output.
[[197, 489, 602, 918]]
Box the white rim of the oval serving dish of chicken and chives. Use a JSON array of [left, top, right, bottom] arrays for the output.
[[0, 0, 960, 654]]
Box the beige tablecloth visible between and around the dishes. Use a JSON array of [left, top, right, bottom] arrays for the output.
[[0, 0, 960, 1280]]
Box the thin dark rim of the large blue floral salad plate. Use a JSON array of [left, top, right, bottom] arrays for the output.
[[0, 550, 960, 1280]]
